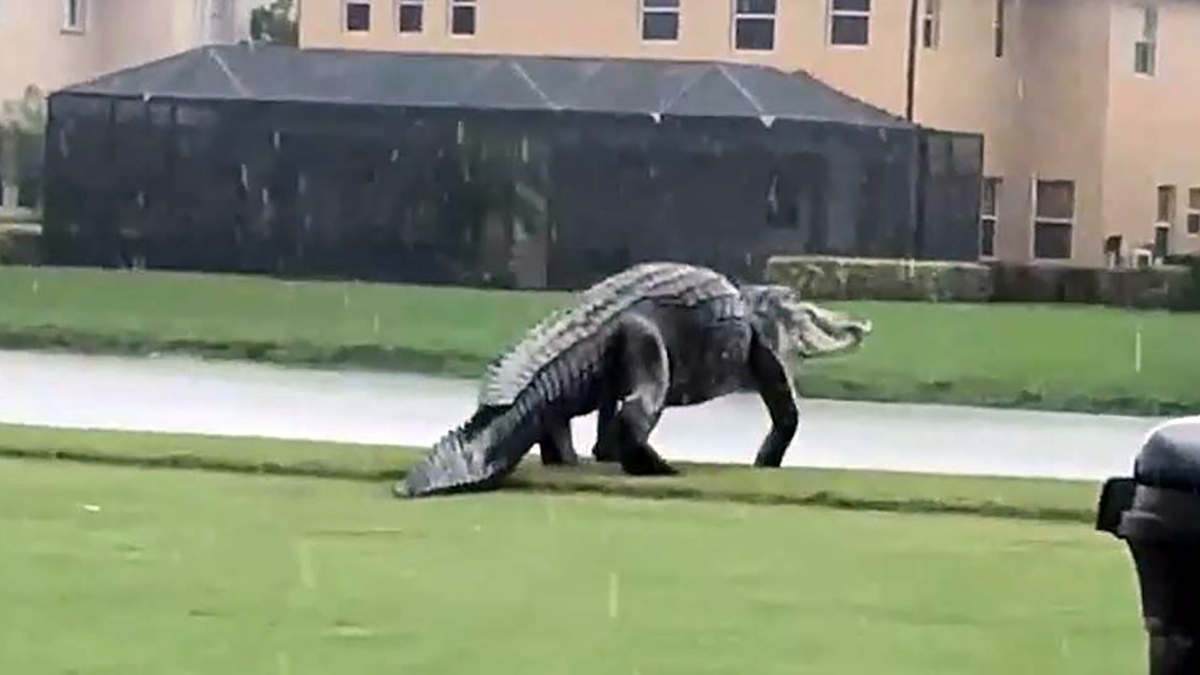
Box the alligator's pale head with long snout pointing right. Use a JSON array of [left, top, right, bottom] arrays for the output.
[[743, 286, 871, 358]]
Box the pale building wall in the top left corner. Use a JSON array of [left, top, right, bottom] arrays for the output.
[[0, 0, 255, 100]]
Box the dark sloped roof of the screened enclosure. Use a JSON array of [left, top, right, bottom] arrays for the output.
[[61, 44, 911, 127]]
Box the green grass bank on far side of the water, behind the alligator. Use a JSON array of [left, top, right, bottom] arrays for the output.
[[0, 261, 1200, 414]]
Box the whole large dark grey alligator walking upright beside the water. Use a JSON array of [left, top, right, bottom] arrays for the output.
[[394, 263, 871, 497]]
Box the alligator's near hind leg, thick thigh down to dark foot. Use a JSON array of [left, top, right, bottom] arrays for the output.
[[601, 315, 677, 476]]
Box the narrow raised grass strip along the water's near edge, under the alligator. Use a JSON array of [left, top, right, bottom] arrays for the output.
[[0, 425, 1100, 524]]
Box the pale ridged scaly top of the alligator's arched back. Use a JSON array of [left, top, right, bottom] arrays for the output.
[[479, 263, 738, 406]]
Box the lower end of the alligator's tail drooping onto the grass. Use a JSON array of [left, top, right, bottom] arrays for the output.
[[394, 400, 538, 497]]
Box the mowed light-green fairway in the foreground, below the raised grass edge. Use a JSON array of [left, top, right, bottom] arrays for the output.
[[0, 460, 1145, 675]]
